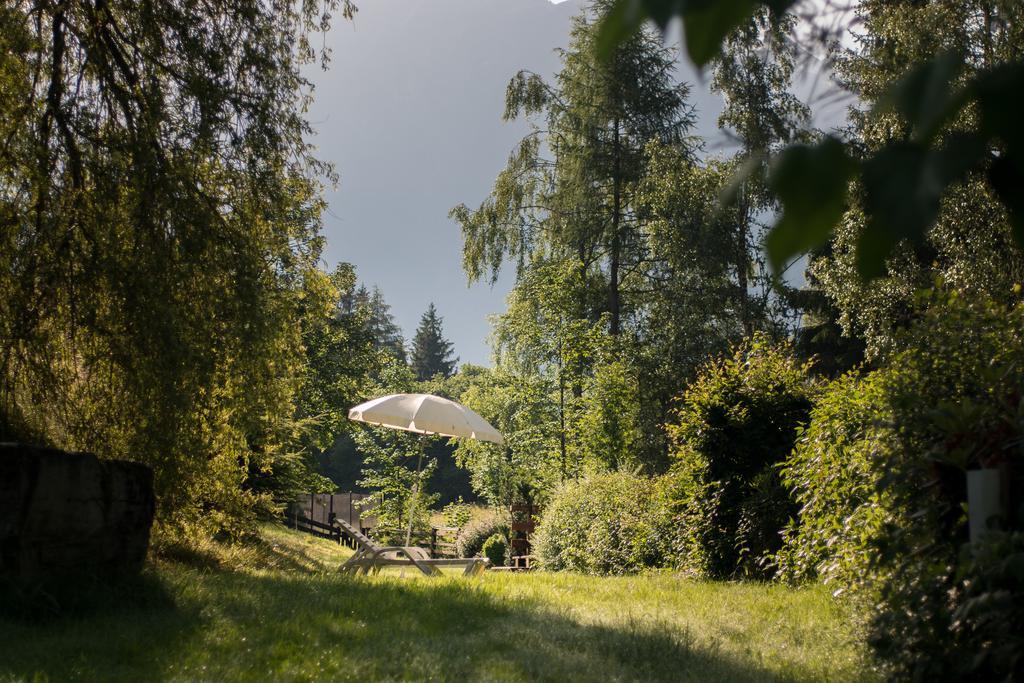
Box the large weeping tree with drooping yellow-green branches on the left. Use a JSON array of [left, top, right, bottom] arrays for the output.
[[0, 0, 353, 531]]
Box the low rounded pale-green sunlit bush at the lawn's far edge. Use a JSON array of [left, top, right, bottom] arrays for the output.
[[534, 472, 666, 574]]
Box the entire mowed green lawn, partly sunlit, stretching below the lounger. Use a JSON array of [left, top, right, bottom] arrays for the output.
[[0, 525, 871, 681]]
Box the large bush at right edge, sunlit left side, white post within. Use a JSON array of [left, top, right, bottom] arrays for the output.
[[779, 294, 1024, 680]]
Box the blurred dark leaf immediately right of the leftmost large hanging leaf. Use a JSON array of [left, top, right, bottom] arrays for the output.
[[857, 134, 985, 279]]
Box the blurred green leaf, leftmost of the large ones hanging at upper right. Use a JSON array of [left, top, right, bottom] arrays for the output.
[[765, 136, 857, 271]]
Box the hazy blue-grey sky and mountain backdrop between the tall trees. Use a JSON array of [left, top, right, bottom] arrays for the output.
[[306, 0, 839, 365]]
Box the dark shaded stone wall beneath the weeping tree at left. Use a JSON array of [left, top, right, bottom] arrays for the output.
[[0, 443, 155, 582]]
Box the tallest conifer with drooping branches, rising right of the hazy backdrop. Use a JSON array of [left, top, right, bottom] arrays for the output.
[[452, 2, 693, 336]]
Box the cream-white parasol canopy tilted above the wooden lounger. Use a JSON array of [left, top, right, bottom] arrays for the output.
[[348, 393, 505, 443]]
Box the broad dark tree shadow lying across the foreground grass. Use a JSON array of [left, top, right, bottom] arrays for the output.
[[0, 569, 802, 682]]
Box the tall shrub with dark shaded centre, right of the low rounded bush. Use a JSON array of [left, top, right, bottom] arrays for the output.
[[668, 335, 814, 579]]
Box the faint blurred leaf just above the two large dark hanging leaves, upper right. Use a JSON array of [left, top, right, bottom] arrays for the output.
[[878, 52, 969, 140]]
